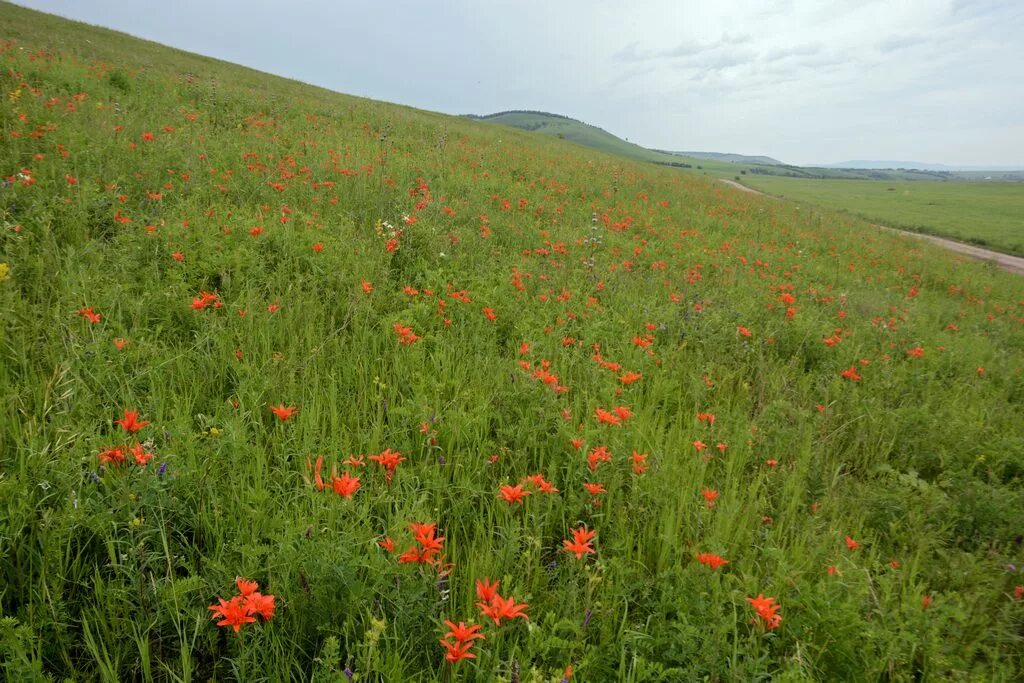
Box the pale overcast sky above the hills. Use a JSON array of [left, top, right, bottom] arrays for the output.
[[9, 0, 1024, 166]]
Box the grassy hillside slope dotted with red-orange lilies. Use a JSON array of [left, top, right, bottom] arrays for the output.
[[0, 4, 1024, 681]]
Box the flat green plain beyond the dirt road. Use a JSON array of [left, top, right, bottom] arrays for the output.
[[741, 174, 1024, 256]]
